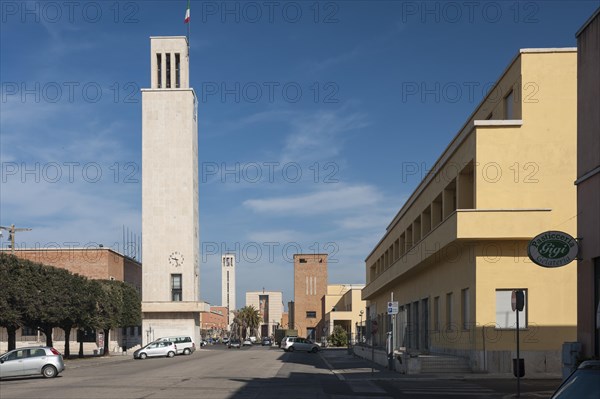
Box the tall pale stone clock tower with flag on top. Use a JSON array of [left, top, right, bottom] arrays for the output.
[[142, 36, 205, 343]]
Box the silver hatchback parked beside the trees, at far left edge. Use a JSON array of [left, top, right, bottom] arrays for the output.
[[0, 346, 65, 378]]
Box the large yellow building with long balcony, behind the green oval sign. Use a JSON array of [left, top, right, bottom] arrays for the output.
[[362, 48, 577, 373]]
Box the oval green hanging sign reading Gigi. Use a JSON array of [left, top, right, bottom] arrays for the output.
[[527, 231, 579, 267]]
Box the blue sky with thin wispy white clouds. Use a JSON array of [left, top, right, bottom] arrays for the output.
[[0, 0, 600, 306]]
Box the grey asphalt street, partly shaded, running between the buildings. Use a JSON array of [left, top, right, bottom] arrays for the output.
[[0, 345, 559, 399]]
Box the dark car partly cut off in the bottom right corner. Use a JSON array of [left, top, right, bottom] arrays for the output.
[[550, 360, 600, 399]]
